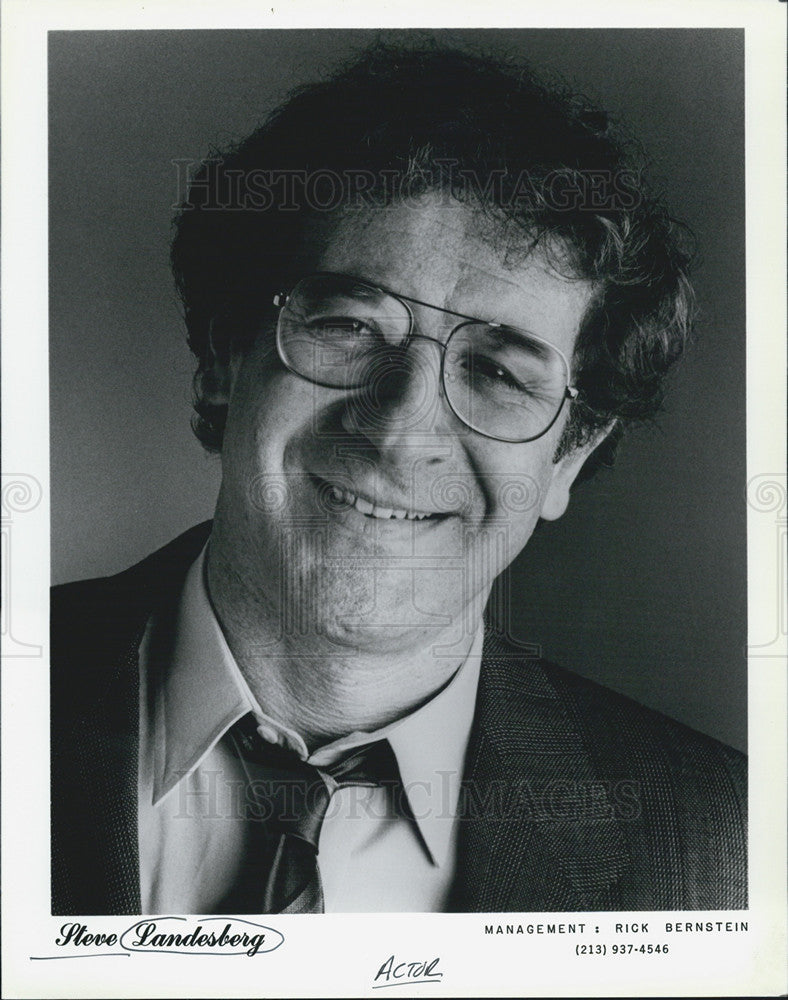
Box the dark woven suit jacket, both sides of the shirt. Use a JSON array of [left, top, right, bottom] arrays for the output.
[[51, 524, 747, 914]]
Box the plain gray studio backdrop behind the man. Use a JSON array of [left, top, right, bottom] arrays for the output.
[[49, 30, 746, 747]]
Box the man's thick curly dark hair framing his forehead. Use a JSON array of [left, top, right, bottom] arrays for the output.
[[172, 44, 693, 474]]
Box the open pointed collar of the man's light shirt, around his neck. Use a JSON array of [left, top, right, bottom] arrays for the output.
[[153, 546, 484, 865]]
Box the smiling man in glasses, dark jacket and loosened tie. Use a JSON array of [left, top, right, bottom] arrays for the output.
[[52, 41, 746, 913]]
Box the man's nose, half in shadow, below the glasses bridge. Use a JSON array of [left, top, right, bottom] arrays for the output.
[[342, 333, 457, 455]]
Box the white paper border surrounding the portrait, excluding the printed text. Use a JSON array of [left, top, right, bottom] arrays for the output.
[[2, 0, 788, 997]]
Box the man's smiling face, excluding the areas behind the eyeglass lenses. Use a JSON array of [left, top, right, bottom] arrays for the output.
[[210, 196, 592, 652]]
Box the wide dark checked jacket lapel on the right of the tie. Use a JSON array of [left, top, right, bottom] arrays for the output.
[[450, 633, 629, 912]]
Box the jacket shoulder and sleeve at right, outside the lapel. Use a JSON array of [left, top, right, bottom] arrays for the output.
[[545, 665, 748, 910]]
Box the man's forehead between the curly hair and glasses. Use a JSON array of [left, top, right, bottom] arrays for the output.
[[300, 195, 593, 353]]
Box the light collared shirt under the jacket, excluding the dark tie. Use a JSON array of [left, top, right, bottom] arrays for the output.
[[138, 550, 483, 913]]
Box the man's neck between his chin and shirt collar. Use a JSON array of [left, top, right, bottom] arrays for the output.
[[207, 562, 484, 750]]
